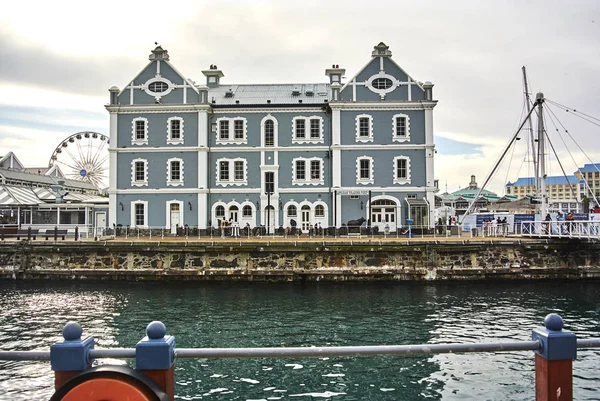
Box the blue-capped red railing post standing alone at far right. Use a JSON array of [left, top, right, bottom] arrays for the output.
[[531, 313, 577, 401]]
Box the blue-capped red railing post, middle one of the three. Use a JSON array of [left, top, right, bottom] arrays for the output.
[[135, 321, 175, 401]]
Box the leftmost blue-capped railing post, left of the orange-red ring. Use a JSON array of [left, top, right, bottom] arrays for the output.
[[50, 322, 94, 390]]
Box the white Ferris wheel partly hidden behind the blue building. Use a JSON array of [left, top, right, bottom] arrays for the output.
[[48, 131, 110, 189]]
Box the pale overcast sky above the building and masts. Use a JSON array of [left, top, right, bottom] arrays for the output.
[[0, 0, 600, 193]]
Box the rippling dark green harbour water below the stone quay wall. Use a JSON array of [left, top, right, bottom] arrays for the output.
[[0, 282, 600, 400]]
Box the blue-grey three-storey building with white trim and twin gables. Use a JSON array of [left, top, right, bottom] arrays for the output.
[[106, 43, 437, 232]]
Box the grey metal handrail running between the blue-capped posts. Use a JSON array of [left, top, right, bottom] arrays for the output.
[[0, 338, 600, 361]]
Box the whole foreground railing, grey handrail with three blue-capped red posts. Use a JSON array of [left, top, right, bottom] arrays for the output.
[[0, 314, 600, 401]]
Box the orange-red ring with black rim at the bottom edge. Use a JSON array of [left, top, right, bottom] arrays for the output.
[[50, 365, 169, 401]]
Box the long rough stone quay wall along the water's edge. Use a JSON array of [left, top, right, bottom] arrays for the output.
[[0, 239, 600, 282]]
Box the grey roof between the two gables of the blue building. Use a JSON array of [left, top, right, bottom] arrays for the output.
[[208, 83, 329, 106]]
